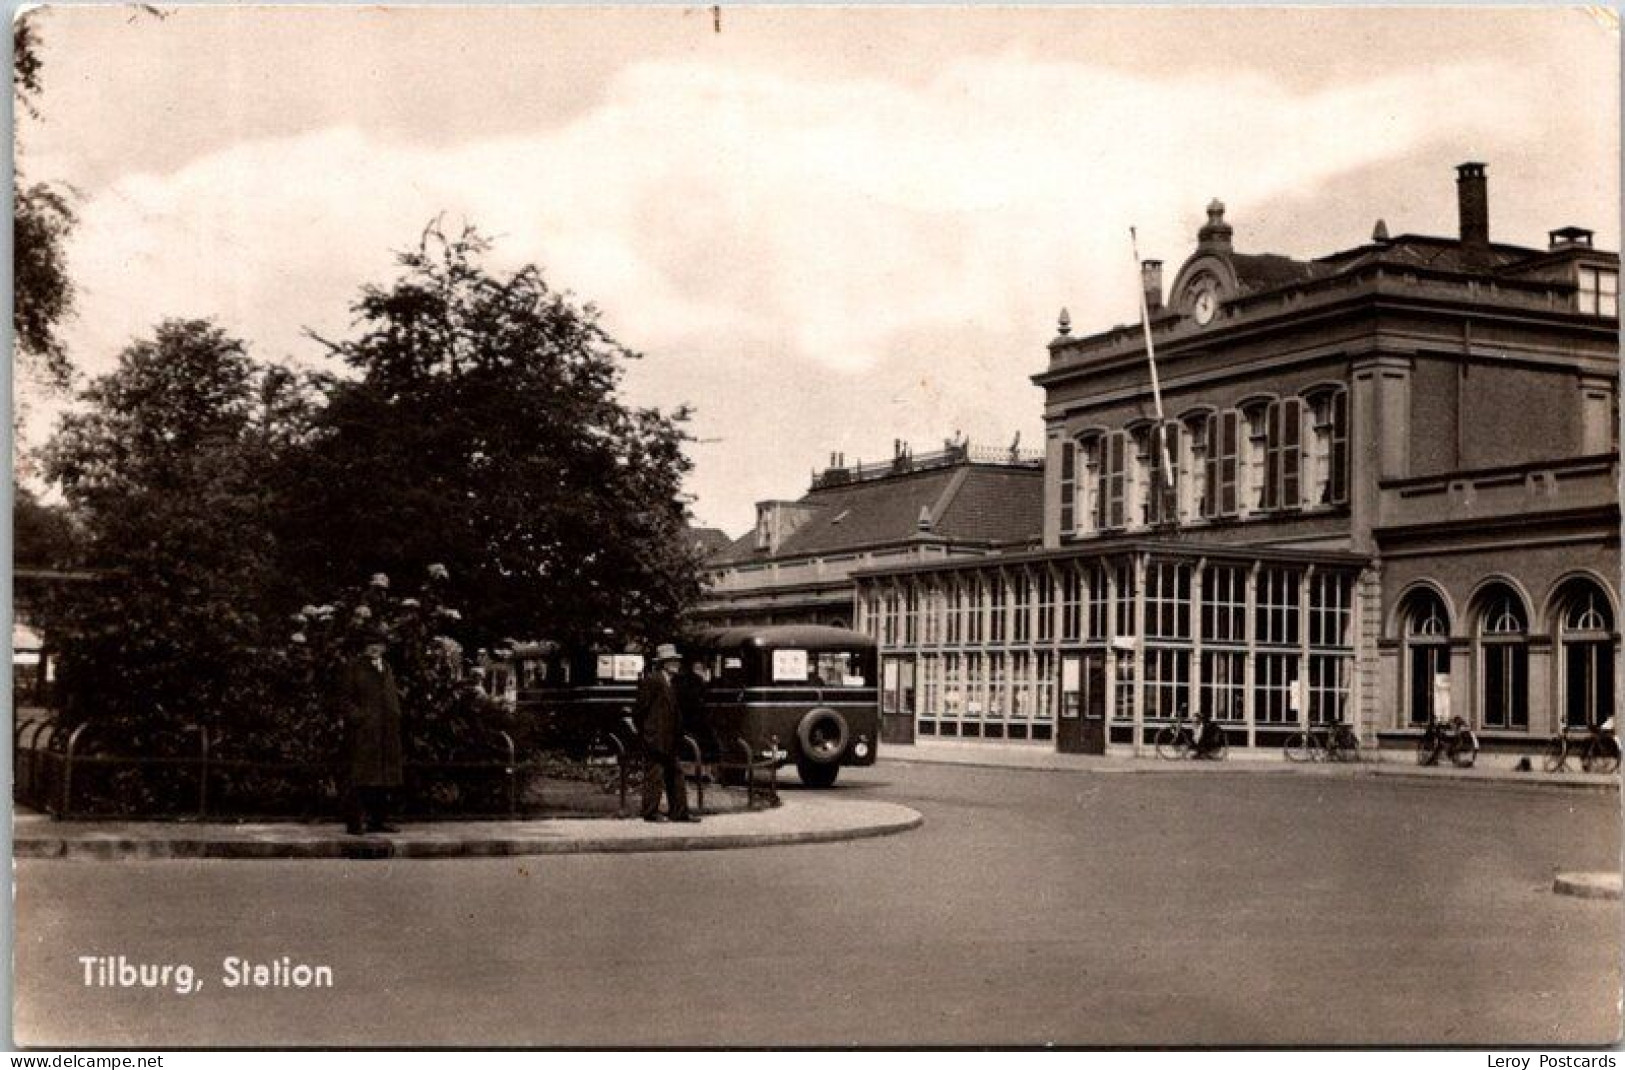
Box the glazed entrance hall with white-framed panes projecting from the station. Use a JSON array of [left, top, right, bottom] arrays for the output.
[[856, 543, 1362, 753]]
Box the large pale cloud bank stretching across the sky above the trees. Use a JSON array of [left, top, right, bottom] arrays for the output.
[[34, 52, 1542, 532]]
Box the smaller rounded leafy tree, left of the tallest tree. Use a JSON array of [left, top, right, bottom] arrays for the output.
[[44, 320, 309, 733]]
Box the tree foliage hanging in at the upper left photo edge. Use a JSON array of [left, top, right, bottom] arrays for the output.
[[11, 13, 75, 387]]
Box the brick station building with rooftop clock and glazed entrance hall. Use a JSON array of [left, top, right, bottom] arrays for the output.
[[852, 163, 1620, 753]]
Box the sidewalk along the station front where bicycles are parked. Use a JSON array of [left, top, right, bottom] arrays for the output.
[[881, 742, 1620, 792]]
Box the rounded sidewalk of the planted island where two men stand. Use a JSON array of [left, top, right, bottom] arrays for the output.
[[11, 792, 923, 860]]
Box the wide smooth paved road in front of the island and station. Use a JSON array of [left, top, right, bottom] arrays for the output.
[[16, 764, 1622, 1047]]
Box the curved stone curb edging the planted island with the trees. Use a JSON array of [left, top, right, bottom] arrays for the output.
[[13, 802, 925, 862]]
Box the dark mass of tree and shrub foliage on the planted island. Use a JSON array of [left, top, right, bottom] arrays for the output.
[[31, 226, 699, 813]]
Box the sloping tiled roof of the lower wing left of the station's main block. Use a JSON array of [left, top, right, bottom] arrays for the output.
[[712, 462, 1043, 566]]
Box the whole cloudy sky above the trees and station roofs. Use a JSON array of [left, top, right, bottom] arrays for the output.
[[16, 7, 1620, 535]]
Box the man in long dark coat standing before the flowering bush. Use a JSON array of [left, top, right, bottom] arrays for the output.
[[338, 634, 405, 836]]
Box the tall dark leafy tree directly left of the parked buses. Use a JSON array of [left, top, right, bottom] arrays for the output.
[[283, 224, 697, 642]]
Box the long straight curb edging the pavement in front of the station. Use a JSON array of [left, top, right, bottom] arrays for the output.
[[882, 751, 1620, 795]]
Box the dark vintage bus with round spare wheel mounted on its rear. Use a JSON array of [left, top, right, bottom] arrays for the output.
[[695, 624, 881, 787]]
